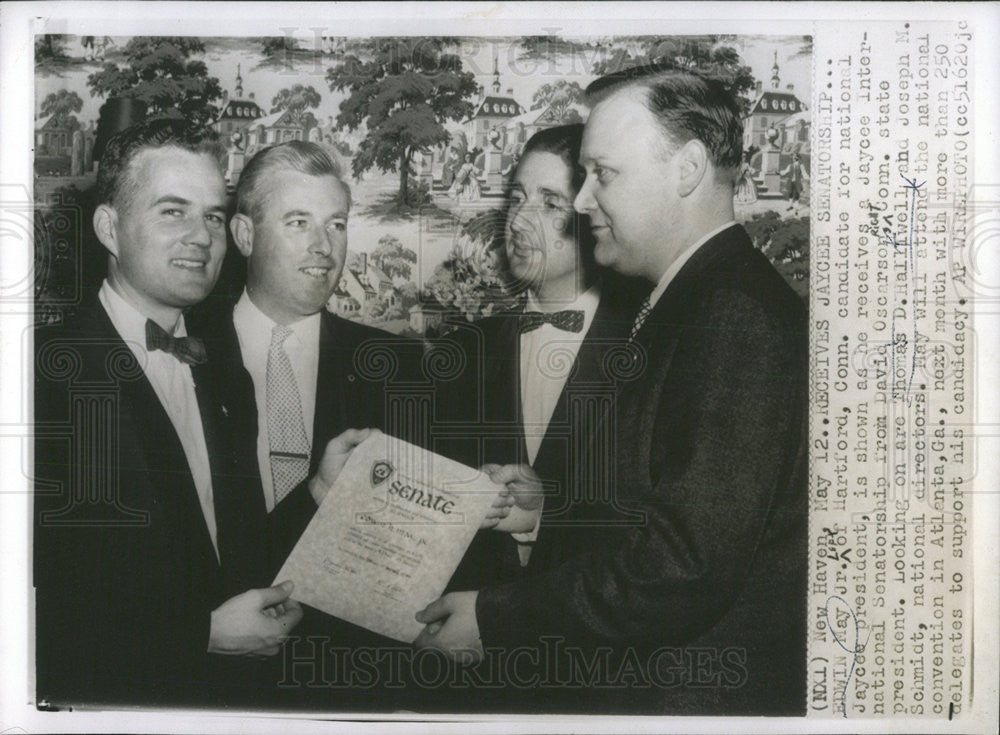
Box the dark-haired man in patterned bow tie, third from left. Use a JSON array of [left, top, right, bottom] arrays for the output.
[[436, 124, 642, 589]]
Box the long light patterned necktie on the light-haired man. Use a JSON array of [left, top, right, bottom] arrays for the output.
[[267, 324, 309, 505]]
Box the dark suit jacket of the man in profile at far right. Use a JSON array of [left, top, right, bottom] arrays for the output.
[[476, 227, 808, 714]]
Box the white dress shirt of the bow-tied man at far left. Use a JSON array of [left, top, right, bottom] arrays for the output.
[[98, 281, 219, 556]]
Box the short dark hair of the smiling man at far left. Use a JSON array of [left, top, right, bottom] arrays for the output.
[[97, 118, 225, 208]]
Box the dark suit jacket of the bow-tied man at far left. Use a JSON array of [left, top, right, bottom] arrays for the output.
[[34, 300, 301, 705]]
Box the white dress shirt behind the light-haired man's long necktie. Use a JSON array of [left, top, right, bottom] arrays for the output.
[[233, 290, 320, 512]]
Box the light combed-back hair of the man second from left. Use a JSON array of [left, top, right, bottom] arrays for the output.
[[236, 140, 351, 223]]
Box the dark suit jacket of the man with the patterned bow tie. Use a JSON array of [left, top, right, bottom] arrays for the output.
[[437, 274, 648, 590]]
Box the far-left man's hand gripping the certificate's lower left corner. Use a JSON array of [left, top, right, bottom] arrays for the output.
[[208, 582, 302, 656]]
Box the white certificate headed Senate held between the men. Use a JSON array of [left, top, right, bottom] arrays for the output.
[[276, 432, 499, 643]]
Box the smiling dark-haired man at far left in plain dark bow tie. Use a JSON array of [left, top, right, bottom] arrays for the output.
[[34, 120, 360, 706]]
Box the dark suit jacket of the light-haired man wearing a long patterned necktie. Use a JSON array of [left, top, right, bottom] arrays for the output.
[[189, 298, 432, 711]]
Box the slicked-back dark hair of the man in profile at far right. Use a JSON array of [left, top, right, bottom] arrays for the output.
[[584, 66, 743, 181]]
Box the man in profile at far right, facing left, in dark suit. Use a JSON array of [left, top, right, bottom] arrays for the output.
[[418, 68, 808, 714]]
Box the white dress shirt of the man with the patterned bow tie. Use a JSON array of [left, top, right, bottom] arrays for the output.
[[511, 285, 601, 566]]
